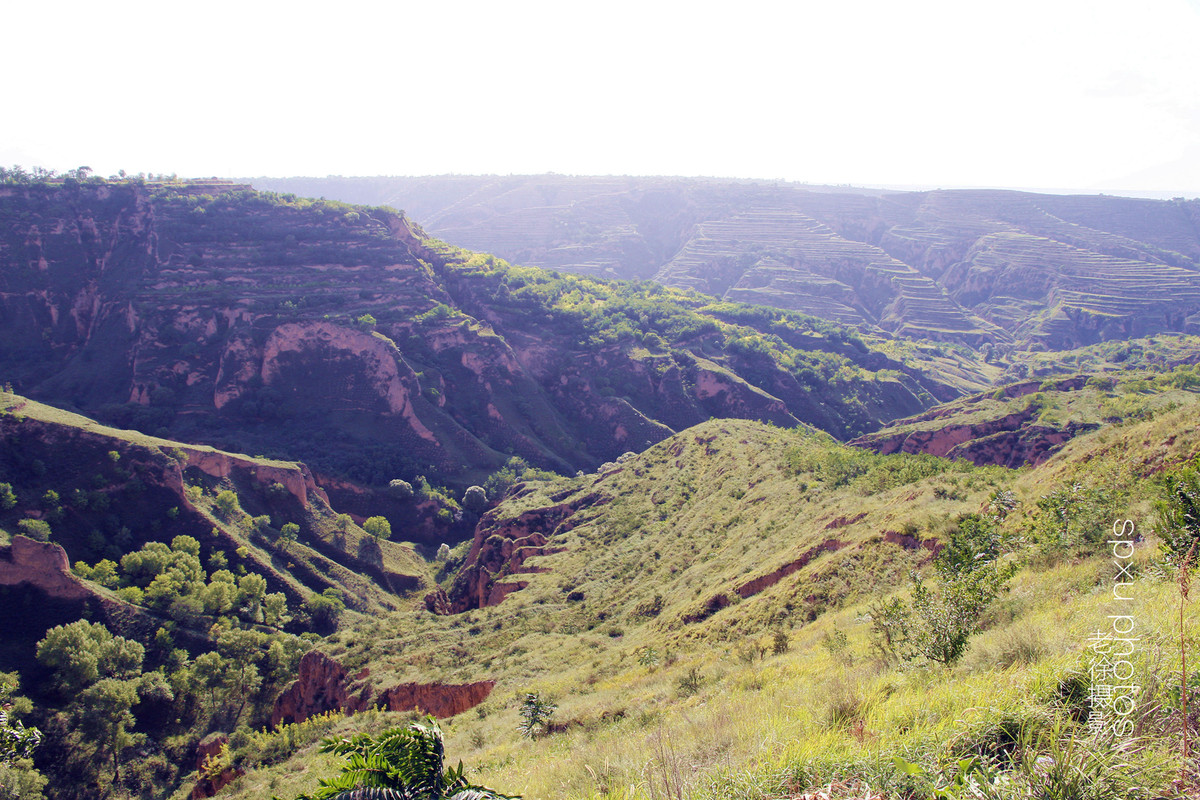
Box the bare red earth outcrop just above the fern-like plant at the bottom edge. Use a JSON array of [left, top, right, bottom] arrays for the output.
[[271, 650, 496, 726]]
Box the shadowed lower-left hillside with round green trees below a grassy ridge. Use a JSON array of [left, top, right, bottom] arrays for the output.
[[0, 392, 431, 798]]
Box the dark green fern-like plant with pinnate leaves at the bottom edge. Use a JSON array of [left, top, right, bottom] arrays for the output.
[[296, 717, 520, 800]]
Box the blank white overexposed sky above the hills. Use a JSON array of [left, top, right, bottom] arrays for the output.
[[7, 0, 1200, 197]]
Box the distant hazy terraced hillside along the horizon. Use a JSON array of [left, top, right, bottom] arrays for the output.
[[256, 175, 1200, 349]]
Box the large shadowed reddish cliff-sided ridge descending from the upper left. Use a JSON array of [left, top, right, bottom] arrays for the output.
[[0, 185, 953, 492]]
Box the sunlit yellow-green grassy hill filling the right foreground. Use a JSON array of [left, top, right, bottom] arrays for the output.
[[211, 393, 1200, 799]]
